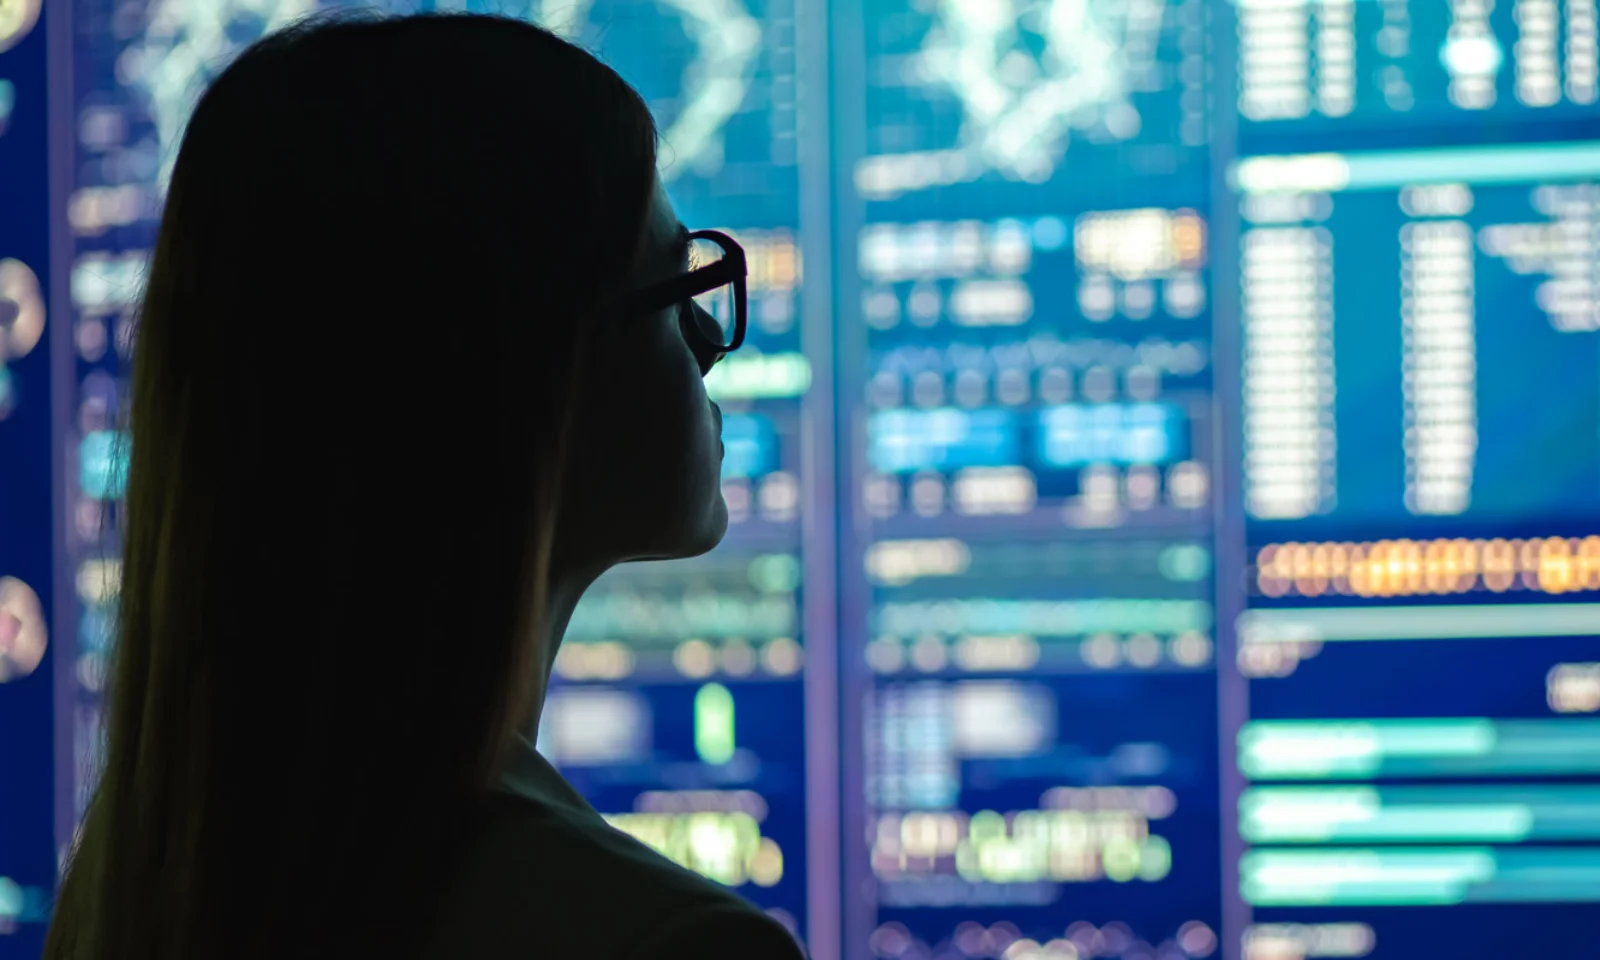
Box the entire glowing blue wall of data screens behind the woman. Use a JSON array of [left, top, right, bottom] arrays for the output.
[[21, 0, 1600, 960]]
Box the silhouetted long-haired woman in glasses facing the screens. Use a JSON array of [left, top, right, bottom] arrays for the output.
[[46, 16, 798, 960]]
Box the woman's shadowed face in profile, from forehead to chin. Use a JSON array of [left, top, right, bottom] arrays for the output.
[[555, 174, 728, 566]]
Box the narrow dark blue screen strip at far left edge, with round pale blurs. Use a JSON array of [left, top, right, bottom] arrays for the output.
[[0, 0, 58, 957]]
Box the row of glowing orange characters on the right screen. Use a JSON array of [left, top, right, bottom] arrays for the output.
[[1256, 536, 1600, 597]]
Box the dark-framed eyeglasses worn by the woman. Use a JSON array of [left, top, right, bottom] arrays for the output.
[[619, 230, 747, 373]]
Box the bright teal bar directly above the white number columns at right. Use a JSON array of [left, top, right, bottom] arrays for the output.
[[1230, 141, 1600, 194]]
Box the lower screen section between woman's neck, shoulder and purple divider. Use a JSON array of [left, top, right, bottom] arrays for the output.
[[556, 539, 806, 933]]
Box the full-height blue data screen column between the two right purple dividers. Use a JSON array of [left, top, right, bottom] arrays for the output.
[[835, 0, 1221, 957]]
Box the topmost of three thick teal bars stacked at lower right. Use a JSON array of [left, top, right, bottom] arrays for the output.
[[1238, 717, 1600, 781]]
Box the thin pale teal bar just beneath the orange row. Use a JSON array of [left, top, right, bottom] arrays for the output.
[[1238, 603, 1600, 643]]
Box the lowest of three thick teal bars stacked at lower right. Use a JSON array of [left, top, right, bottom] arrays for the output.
[[1238, 846, 1600, 907]]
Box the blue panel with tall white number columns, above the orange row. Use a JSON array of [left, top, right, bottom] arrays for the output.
[[1237, 142, 1600, 534]]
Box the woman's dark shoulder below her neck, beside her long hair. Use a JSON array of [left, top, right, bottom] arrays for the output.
[[435, 800, 798, 960]]
